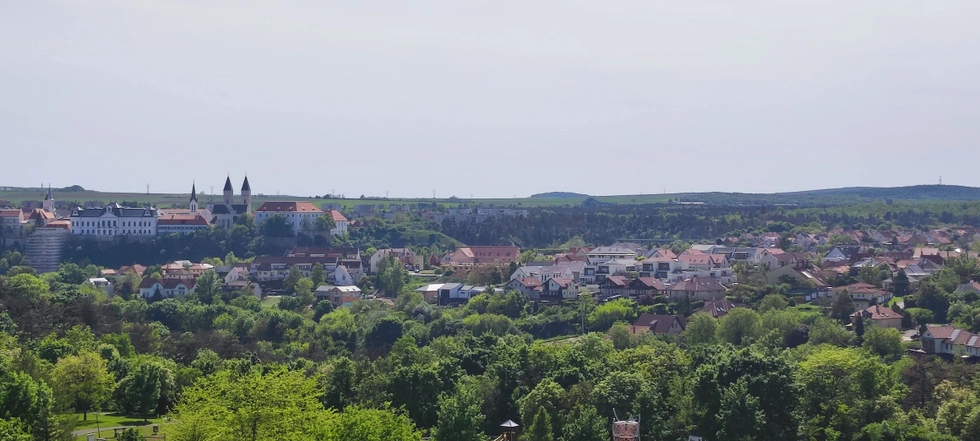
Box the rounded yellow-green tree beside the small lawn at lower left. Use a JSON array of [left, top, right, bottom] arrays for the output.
[[51, 352, 115, 420]]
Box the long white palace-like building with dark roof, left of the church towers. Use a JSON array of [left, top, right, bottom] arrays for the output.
[[69, 204, 157, 237]]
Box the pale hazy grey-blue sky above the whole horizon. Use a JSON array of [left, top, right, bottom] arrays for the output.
[[0, 0, 980, 197]]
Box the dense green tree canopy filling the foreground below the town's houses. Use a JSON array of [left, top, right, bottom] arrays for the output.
[[0, 253, 980, 441]]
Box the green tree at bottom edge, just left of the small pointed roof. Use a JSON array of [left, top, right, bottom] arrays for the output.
[[432, 384, 486, 441]]
